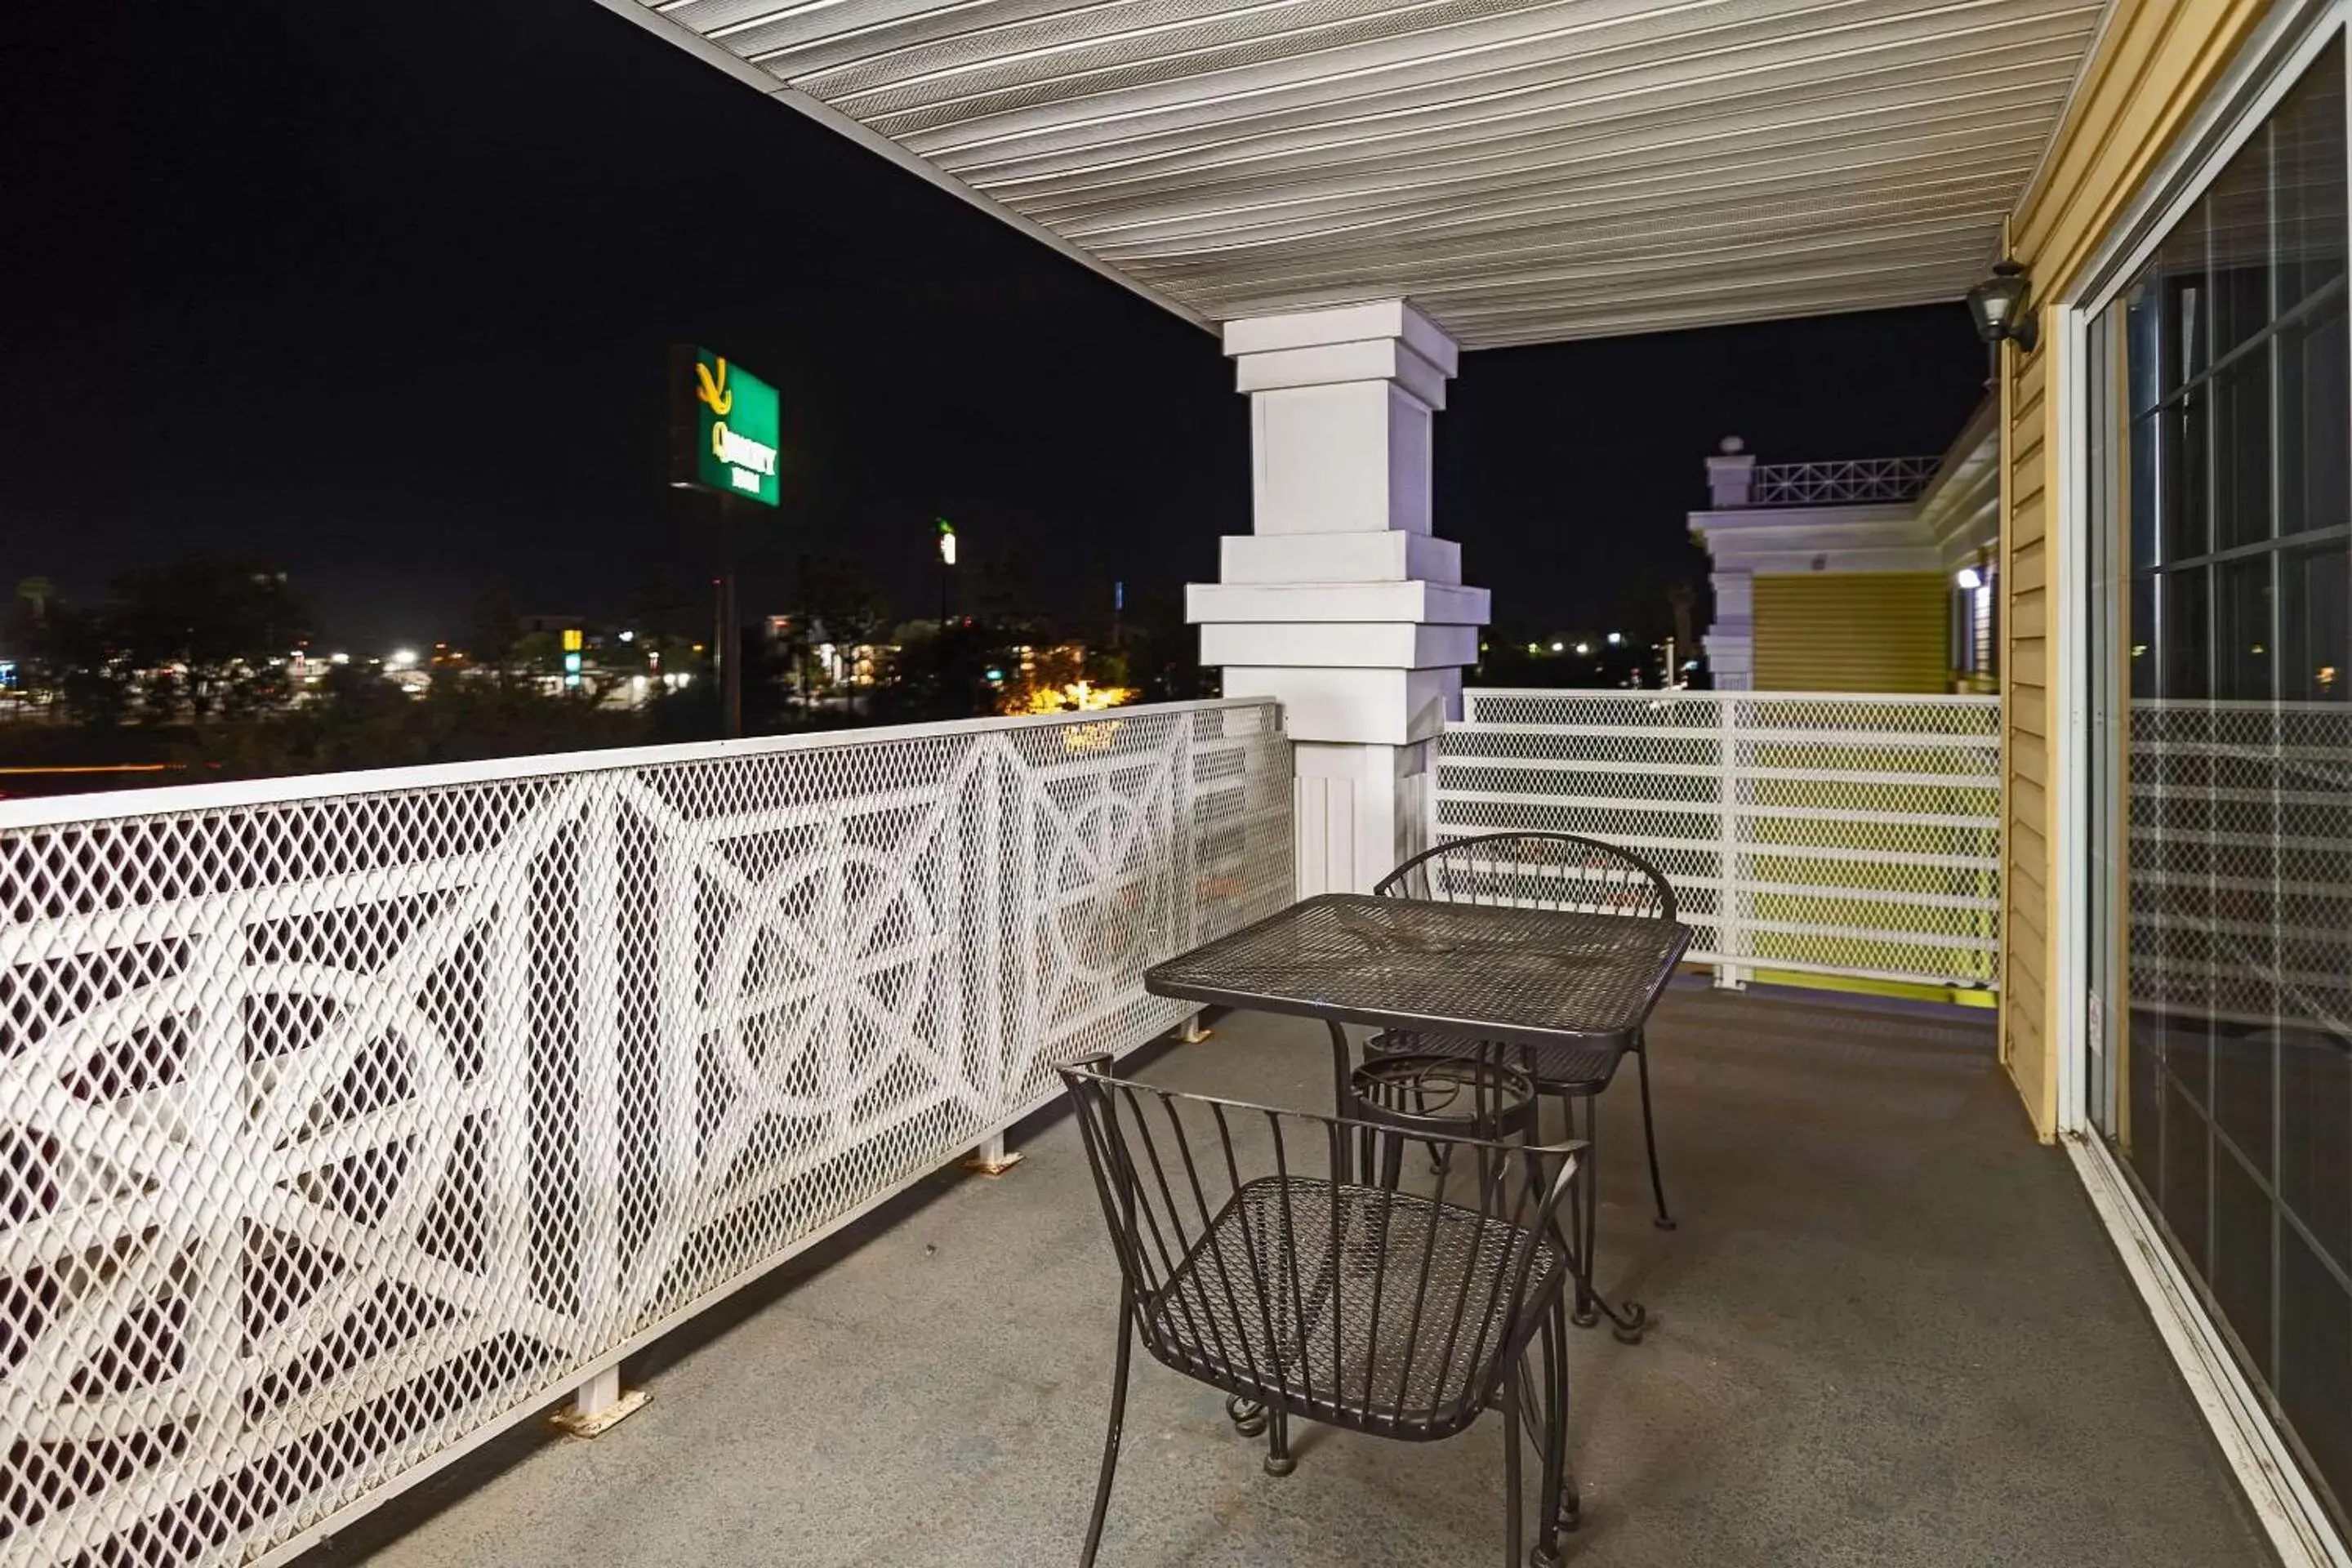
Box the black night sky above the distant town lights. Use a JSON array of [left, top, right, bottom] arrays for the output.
[[0, 0, 1985, 648]]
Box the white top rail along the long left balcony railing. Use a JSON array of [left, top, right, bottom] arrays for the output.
[[0, 696, 1275, 832]]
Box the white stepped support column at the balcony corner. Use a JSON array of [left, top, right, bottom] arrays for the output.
[[1186, 301, 1486, 893]]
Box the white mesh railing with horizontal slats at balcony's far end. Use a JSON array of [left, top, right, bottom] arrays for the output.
[[1432, 691, 2002, 987]]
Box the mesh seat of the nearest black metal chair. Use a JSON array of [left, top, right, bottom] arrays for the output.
[[1138, 1175, 1566, 1439]]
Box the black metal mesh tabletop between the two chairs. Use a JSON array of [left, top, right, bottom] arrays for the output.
[[1143, 893, 1691, 1046]]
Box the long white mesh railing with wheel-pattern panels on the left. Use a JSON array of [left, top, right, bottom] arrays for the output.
[[0, 701, 1291, 1566]]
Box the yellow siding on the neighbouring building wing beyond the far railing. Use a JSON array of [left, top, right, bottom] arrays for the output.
[[1754, 571, 1952, 691]]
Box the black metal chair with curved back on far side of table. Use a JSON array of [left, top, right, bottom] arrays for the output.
[[1364, 832, 1675, 1340]]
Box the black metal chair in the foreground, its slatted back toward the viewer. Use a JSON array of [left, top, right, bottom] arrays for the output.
[[1061, 1055, 1580, 1568]]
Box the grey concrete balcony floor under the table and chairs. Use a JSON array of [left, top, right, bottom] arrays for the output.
[[304, 985, 2272, 1568]]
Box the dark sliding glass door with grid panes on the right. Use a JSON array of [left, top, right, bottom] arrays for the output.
[[2084, 45, 2352, 1517]]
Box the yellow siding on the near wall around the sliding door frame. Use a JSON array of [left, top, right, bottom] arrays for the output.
[[2002, 0, 2265, 1138]]
